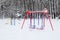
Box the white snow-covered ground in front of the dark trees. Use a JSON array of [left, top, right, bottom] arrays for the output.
[[0, 19, 60, 40]]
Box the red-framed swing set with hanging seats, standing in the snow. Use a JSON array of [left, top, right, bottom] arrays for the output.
[[21, 8, 54, 30]]
